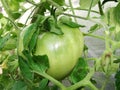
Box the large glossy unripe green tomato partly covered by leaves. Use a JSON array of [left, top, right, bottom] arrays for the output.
[[18, 23, 84, 80]]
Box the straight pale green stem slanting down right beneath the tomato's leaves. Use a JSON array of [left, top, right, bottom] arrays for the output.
[[33, 70, 66, 90]]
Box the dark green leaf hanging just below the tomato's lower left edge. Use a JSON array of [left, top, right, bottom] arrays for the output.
[[18, 56, 33, 81]]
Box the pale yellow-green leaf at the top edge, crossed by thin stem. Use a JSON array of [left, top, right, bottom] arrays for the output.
[[79, 0, 99, 8]]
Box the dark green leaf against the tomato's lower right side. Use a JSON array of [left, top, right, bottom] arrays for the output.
[[69, 58, 89, 83]]
